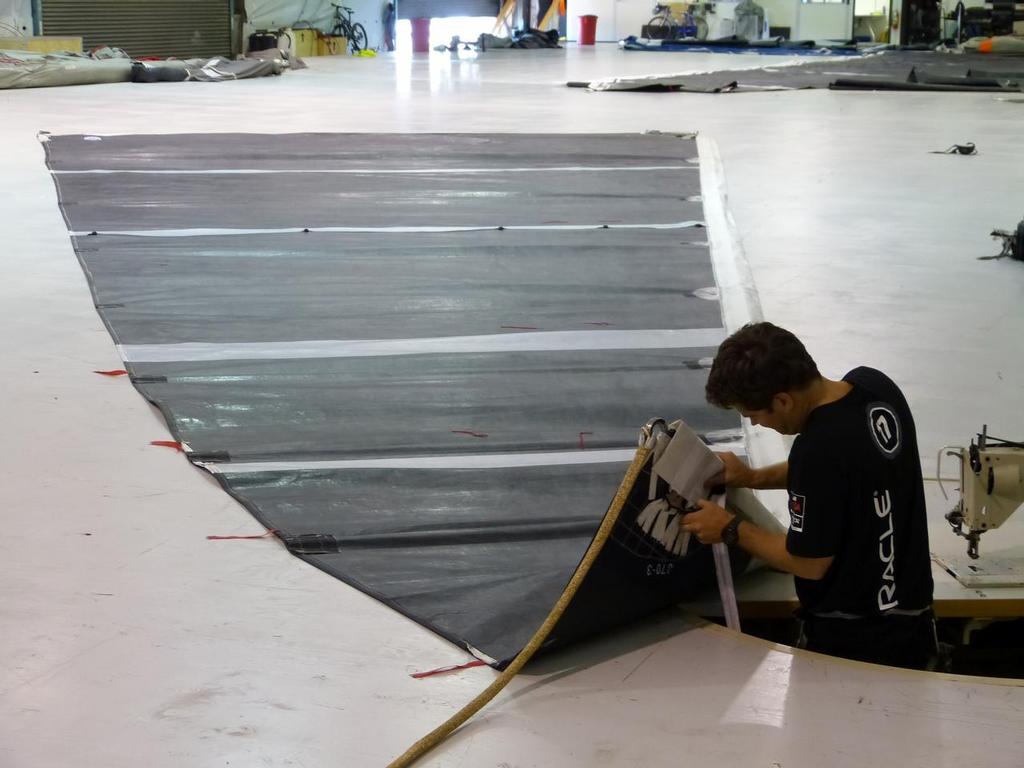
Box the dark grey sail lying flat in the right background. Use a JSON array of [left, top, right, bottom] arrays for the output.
[[570, 50, 1024, 93]]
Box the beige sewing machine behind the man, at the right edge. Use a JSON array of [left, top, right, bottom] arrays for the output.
[[939, 425, 1024, 560]]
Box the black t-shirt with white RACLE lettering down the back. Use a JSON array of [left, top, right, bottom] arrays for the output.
[[785, 368, 932, 616]]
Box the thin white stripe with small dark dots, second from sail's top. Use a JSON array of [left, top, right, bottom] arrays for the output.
[[70, 221, 705, 238]]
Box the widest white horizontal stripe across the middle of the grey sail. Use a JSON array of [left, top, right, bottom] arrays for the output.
[[118, 328, 725, 362]]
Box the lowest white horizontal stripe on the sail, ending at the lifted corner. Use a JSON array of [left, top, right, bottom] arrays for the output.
[[197, 449, 636, 475]]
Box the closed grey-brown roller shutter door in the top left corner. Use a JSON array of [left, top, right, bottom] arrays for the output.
[[41, 0, 231, 58]]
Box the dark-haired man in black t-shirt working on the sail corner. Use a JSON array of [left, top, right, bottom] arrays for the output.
[[683, 323, 936, 669]]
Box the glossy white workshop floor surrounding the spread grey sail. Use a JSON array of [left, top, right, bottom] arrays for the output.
[[0, 46, 1024, 768]]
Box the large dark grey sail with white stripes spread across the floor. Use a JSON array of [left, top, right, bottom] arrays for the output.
[[46, 134, 738, 659]]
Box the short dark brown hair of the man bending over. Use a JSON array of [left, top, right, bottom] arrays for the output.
[[705, 323, 820, 411]]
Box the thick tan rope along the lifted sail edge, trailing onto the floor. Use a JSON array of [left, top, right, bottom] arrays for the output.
[[387, 446, 650, 768]]
